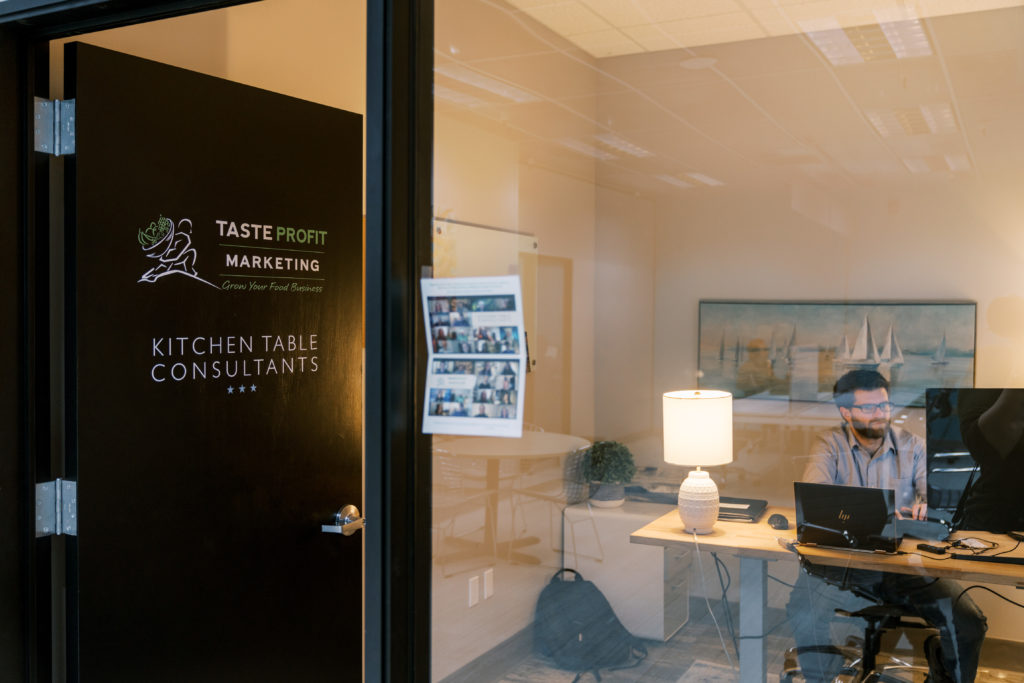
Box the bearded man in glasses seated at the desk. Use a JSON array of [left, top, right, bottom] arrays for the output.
[[786, 370, 986, 682]]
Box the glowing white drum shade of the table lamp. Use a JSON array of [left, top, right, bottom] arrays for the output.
[[662, 389, 732, 467]]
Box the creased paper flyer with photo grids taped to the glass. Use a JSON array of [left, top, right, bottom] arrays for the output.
[[421, 275, 526, 437]]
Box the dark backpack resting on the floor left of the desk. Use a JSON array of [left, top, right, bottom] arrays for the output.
[[534, 569, 647, 683]]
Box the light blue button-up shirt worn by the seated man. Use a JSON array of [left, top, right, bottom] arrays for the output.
[[803, 424, 928, 509]]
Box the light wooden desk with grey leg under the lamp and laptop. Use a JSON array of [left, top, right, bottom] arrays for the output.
[[630, 507, 1024, 683]]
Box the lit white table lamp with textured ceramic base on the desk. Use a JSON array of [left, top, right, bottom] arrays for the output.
[[662, 389, 732, 533]]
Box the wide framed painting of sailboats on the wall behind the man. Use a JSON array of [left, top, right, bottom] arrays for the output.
[[698, 300, 977, 407]]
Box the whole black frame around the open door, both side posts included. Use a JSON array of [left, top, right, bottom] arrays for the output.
[[0, 0, 433, 682]]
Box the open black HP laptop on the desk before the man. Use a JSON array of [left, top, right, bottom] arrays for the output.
[[793, 481, 900, 553]]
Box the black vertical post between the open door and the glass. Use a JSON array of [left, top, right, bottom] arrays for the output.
[[365, 0, 434, 681]]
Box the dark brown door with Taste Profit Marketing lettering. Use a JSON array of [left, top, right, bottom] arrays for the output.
[[66, 44, 362, 683]]
